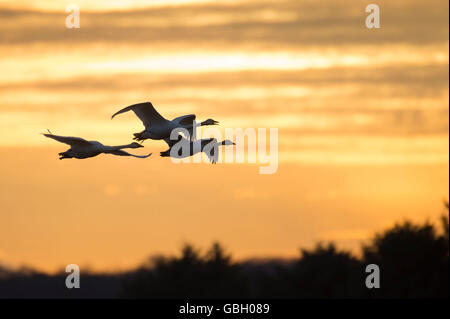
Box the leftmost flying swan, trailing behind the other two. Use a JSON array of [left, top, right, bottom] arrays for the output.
[[43, 133, 152, 160]]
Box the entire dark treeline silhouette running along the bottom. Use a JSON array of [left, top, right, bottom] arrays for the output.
[[0, 205, 449, 298]]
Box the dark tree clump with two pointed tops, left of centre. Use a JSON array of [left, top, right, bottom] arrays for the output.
[[124, 243, 245, 298]]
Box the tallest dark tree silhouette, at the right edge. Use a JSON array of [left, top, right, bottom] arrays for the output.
[[363, 211, 448, 298]]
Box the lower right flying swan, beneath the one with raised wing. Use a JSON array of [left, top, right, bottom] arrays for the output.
[[160, 135, 236, 164]]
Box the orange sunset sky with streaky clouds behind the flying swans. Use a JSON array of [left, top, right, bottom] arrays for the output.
[[0, 0, 449, 272]]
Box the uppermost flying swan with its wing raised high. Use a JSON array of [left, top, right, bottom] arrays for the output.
[[111, 102, 219, 141]]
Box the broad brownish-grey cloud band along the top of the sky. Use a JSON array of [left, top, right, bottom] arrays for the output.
[[0, 0, 449, 45]]
